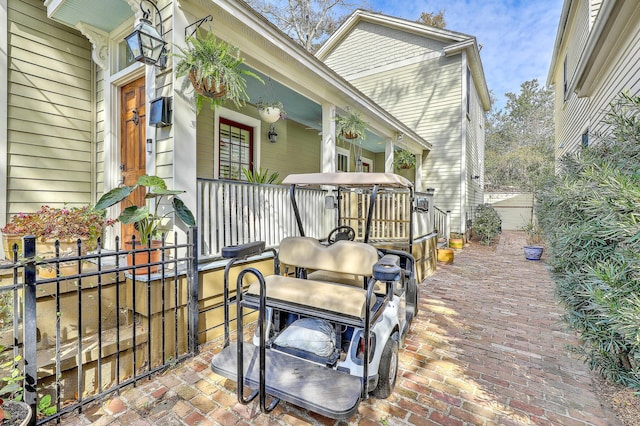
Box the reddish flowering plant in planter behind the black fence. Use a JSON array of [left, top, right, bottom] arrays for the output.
[[2, 206, 116, 250]]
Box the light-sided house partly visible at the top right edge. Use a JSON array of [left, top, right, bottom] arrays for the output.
[[547, 0, 640, 159]]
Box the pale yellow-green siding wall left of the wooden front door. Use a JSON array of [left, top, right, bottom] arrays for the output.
[[3, 0, 95, 214]]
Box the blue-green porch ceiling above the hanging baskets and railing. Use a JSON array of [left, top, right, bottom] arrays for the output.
[[247, 69, 385, 153]]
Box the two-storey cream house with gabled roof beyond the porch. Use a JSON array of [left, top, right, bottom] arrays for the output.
[[316, 10, 490, 232]]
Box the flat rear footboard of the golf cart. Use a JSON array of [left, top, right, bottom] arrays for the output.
[[211, 343, 361, 419]]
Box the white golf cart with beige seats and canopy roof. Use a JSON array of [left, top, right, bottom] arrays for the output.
[[211, 173, 418, 419]]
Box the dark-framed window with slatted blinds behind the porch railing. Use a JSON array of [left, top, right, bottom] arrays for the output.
[[218, 117, 253, 180]]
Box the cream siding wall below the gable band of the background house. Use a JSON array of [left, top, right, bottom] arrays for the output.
[[352, 55, 463, 227]]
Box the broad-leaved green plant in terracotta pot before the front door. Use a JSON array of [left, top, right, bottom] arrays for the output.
[[96, 175, 196, 244]]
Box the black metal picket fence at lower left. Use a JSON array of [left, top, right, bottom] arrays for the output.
[[0, 228, 198, 425]]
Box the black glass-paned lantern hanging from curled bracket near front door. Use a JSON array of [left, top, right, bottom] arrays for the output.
[[124, 0, 167, 68]]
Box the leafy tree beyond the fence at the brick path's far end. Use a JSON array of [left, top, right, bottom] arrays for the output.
[[485, 79, 554, 191]]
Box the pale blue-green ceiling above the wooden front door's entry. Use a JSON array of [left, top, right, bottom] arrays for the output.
[[45, 0, 133, 32]]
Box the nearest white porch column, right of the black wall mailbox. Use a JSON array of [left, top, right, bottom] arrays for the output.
[[171, 7, 198, 239]]
